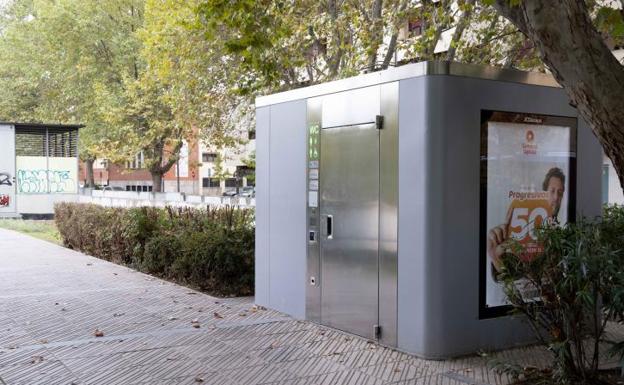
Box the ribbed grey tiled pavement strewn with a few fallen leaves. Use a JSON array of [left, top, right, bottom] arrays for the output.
[[0, 229, 620, 385]]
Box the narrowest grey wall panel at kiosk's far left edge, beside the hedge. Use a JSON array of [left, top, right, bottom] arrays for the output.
[[255, 107, 271, 306]]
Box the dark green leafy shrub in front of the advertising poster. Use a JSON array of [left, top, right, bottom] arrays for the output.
[[500, 207, 624, 383]]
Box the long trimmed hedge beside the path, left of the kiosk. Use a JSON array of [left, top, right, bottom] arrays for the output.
[[54, 203, 254, 296]]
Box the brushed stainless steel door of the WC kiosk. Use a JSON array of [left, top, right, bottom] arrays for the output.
[[320, 124, 379, 338]]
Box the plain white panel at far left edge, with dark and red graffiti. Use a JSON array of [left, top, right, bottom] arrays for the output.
[[0, 126, 16, 215]]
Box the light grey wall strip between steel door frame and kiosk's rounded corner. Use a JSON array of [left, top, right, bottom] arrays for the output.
[[397, 77, 434, 353]]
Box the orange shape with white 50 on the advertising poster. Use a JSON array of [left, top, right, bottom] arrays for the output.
[[507, 192, 552, 261]]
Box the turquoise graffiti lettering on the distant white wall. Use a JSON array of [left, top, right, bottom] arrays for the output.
[[17, 169, 76, 194]]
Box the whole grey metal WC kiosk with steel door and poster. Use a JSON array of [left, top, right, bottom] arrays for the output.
[[256, 62, 602, 358]]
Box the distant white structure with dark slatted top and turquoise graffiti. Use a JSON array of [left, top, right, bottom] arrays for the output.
[[0, 122, 82, 218]]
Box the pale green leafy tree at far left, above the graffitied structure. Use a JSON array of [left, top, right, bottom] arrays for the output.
[[0, 0, 143, 185]]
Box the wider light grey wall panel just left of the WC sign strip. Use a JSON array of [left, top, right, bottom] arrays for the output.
[[269, 100, 307, 318]]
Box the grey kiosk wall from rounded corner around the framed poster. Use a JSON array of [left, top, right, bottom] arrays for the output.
[[399, 76, 600, 358]]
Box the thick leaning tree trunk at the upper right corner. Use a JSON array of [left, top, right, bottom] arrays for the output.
[[494, 0, 624, 188]]
